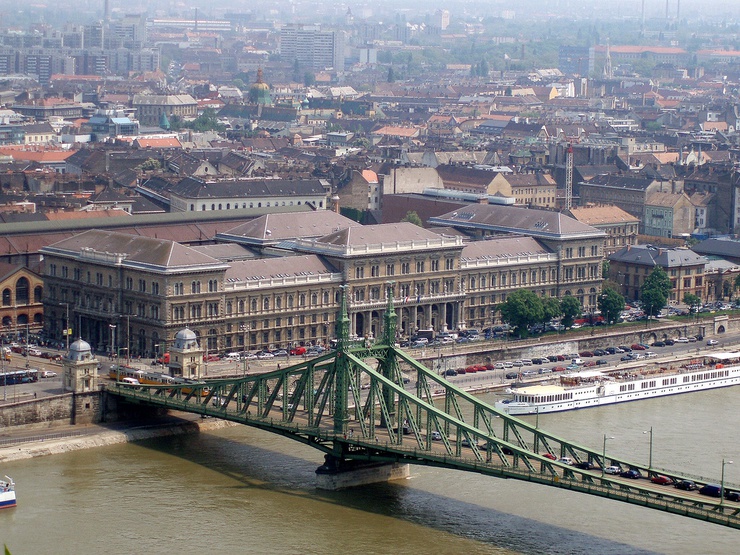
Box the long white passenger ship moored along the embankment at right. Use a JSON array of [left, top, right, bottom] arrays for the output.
[[494, 352, 740, 416]]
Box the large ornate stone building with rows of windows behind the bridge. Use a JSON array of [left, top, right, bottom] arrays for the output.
[[42, 206, 604, 356]]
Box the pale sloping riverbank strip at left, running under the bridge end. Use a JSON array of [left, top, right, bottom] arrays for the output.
[[0, 413, 237, 463]]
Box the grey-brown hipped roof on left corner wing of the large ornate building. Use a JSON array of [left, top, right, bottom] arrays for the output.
[[41, 229, 226, 273]]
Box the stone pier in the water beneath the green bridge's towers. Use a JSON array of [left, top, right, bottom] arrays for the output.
[[316, 455, 410, 491]]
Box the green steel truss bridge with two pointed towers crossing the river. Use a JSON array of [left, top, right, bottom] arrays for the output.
[[107, 298, 740, 528]]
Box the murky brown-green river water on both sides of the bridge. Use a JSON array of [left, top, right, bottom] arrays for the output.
[[0, 387, 740, 555]]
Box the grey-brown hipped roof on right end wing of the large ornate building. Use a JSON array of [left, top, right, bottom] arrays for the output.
[[429, 204, 604, 239]]
